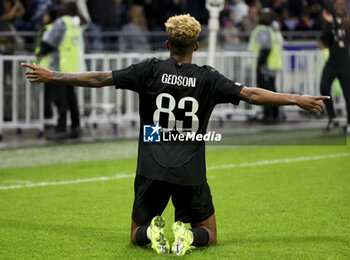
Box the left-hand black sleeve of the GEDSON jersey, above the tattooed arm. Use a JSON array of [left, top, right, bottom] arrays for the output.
[[112, 60, 153, 92]]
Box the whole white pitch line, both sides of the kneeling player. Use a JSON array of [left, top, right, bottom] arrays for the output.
[[0, 153, 350, 190]]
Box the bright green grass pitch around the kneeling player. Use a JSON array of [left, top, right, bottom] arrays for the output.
[[0, 141, 350, 259]]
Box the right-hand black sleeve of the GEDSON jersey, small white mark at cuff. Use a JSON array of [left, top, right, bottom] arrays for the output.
[[209, 68, 243, 105]]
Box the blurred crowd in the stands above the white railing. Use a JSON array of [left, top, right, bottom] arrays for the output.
[[0, 0, 350, 53]]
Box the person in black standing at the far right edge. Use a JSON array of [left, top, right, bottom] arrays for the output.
[[320, 0, 350, 133]]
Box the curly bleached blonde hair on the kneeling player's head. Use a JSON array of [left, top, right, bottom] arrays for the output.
[[165, 14, 201, 55]]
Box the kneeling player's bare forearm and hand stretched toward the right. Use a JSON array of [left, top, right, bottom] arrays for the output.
[[240, 87, 330, 113]]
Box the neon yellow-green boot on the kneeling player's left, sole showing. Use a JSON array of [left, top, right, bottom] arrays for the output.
[[149, 216, 170, 254]]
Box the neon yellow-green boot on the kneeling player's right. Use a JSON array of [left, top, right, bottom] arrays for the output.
[[171, 221, 195, 256]]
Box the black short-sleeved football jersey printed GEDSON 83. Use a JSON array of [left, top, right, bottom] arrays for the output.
[[113, 58, 243, 185]]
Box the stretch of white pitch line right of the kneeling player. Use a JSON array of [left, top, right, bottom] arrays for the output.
[[207, 153, 350, 171]]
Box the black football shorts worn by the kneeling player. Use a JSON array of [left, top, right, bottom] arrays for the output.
[[132, 174, 214, 223]]
